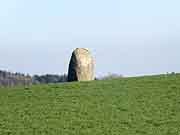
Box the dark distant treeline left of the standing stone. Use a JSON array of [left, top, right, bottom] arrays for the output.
[[0, 70, 67, 87]]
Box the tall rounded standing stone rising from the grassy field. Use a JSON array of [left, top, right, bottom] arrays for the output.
[[68, 48, 94, 82]]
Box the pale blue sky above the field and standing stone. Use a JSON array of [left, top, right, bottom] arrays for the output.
[[0, 0, 180, 76]]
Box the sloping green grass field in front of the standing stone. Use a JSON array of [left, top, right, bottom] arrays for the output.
[[0, 74, 180, 135]]
